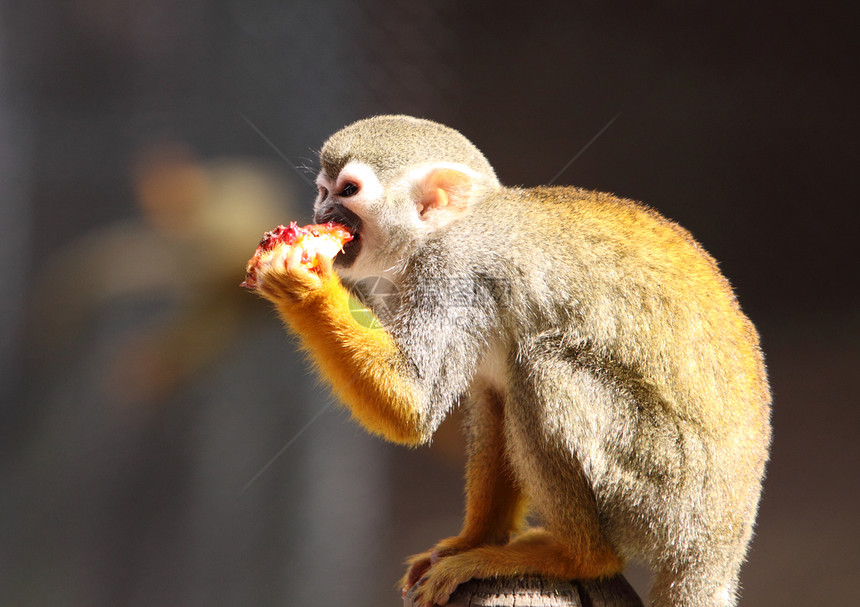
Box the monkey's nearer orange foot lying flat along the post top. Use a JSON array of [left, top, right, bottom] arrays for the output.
[[413, 531, 624, 607]]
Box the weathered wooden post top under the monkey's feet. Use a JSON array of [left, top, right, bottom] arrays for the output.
[[403, 575, 642, 607]]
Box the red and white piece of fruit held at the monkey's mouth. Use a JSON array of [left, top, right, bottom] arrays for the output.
[[240, 221, 352, 289]]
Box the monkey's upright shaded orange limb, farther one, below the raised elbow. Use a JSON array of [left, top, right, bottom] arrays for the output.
[[401, 389, 526, 592]]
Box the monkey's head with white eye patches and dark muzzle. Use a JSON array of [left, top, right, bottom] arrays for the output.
[[314, 116, 500, 280]]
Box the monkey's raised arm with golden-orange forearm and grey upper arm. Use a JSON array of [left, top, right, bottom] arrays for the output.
[[257, 241, 487, 445]]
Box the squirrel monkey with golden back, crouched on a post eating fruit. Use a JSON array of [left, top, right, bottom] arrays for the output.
[[249, 116, 770, 606]]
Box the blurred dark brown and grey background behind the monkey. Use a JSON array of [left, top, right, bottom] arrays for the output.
[[0, 0, 860, 606]]
